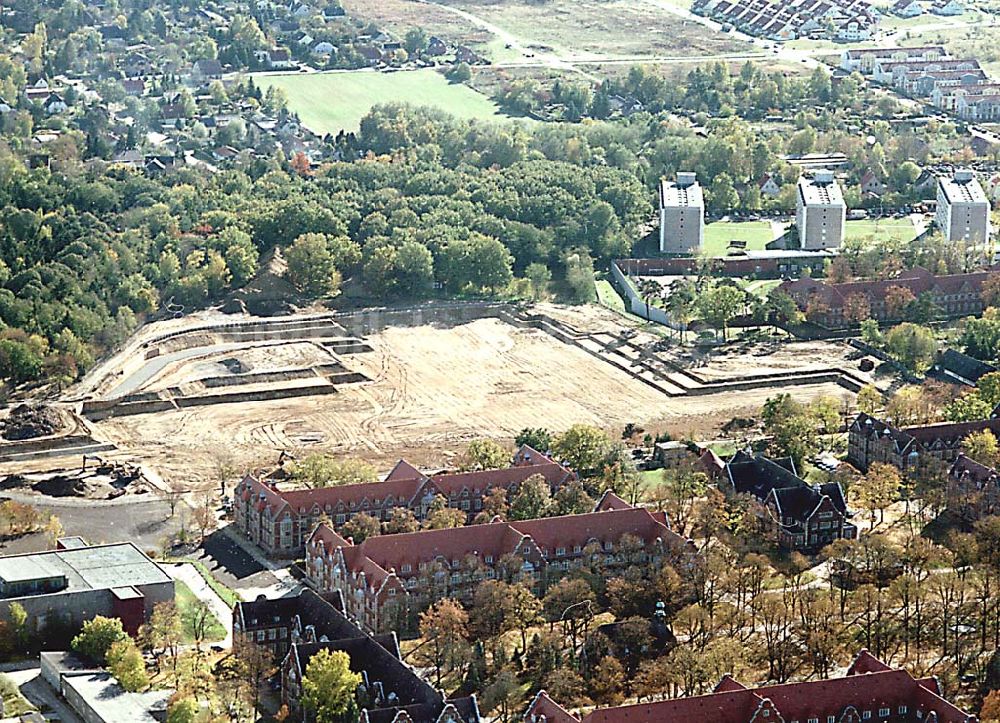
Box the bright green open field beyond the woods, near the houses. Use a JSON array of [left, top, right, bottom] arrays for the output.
[[254, 68, 508, 134]]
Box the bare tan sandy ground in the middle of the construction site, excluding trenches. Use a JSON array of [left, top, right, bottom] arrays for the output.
[[92, 306, 844, 485]]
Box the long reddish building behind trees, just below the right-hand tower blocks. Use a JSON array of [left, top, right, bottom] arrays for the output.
[[779, 267, 997, 329]]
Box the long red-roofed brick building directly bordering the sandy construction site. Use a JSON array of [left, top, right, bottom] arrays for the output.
[[233, 445, 576, 557]]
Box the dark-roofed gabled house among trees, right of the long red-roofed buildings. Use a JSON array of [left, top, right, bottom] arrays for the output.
[[719, 452, 858, 550]]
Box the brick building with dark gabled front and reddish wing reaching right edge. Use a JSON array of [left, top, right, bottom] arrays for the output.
[[847, 413, 1000, 472]]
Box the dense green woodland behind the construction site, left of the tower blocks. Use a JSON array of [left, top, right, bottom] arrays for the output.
[[0, 107, 652, 382]]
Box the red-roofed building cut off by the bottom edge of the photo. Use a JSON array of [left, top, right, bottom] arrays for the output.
[[524, 650, 976, 723]]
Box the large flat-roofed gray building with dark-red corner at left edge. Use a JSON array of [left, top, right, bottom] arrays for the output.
[[0, 542, 174, 642]]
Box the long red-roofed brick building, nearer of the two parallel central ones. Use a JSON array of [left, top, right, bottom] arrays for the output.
[[305, 504, 695, 632]]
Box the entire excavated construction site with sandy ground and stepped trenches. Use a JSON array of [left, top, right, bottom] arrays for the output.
[[0, 302, 876, 494]]
